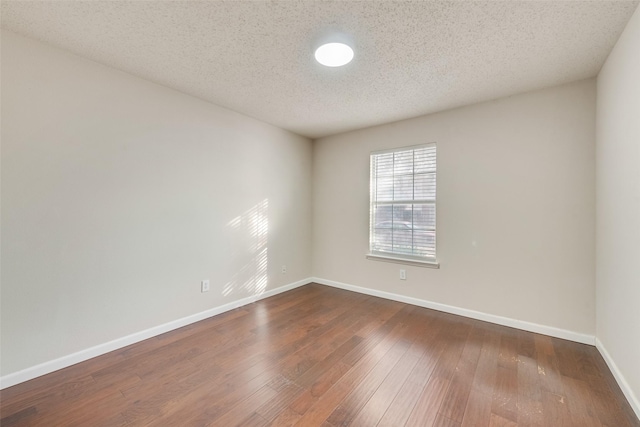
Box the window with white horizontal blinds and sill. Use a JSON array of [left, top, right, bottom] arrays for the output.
[[368, 144, 437, 265]]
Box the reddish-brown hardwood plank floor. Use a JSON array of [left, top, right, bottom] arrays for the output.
[[0, 284, 640, 427]]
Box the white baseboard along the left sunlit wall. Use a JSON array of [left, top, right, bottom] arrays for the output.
[[0, 278, 312, 390]]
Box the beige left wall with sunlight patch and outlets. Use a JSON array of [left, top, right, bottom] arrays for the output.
[[1, 31, 312, 375]]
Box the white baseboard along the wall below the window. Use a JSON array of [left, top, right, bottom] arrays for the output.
[[312, 277, 595, 345]]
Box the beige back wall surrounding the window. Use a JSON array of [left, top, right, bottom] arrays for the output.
[[313, 79, 596, 336]]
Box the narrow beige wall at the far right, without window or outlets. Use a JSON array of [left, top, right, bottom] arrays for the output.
[[596, 4, 640, 416]]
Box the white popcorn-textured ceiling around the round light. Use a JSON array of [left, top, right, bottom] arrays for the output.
[[1, 0, 638, 138]]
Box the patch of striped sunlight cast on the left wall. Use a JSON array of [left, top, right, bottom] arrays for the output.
[[222, 199, 269, 296]]
